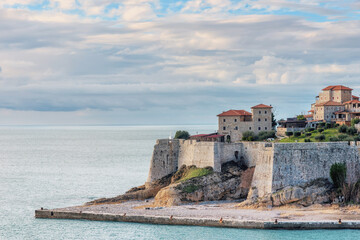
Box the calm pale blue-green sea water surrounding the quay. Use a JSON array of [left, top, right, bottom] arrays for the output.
[[0, 126, 360, 240]]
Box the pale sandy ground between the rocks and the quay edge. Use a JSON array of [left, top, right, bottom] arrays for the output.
[[56, 201, 360, 222]]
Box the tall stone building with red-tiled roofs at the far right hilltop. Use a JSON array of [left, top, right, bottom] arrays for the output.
[[311, 85, 360, 125]]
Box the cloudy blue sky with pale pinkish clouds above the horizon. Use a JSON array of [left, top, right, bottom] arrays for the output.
[[0, 0, 360, 125]]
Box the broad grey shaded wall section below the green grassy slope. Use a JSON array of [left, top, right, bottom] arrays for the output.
[[272, 142, 360, 191]]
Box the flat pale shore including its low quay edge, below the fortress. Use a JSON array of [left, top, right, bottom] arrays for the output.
[[35, 201, 360, 230]]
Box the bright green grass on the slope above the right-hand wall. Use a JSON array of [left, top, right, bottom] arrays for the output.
[[279, 128, 354, 143]]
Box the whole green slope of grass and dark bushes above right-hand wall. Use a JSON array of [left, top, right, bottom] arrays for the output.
[[280, 125, 360, 143]]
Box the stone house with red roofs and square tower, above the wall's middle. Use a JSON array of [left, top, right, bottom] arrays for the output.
[[217, 104, 272, 142]]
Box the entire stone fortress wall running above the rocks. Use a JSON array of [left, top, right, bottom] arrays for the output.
[[147, 139, 360, 197]]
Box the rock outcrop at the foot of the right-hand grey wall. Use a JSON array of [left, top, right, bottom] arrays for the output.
[[239, 178, 333, 207]]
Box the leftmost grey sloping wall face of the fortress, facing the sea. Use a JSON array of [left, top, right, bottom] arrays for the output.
[[146, 139, 180, 183]]
